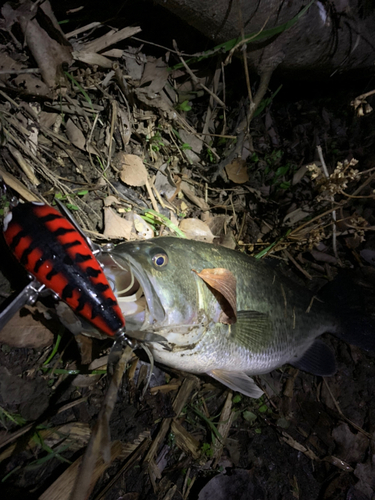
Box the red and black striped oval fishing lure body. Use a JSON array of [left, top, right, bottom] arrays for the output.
[[4, 202, 125, 336]]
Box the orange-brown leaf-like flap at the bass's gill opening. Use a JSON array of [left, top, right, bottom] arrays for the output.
[[193, 267, 237, 325]]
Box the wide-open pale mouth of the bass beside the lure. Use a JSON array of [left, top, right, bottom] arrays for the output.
[[100, 252, 165, 333]]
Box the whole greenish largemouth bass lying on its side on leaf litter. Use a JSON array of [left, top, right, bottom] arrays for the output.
[[105, 237, 374, 398]]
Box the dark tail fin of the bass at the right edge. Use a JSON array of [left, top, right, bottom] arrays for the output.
[[320, 267, 375, 351]]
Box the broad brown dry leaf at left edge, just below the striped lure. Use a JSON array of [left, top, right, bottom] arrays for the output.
[[0, 309, 53, 349]]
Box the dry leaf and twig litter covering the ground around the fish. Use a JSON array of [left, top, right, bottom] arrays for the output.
[[0, 2, 375, 500]]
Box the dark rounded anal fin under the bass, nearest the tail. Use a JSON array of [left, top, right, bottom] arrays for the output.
[[289, 340, 336, 377]]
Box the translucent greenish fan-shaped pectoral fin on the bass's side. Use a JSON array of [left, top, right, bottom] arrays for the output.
[[230, 311, 274, 350]]
